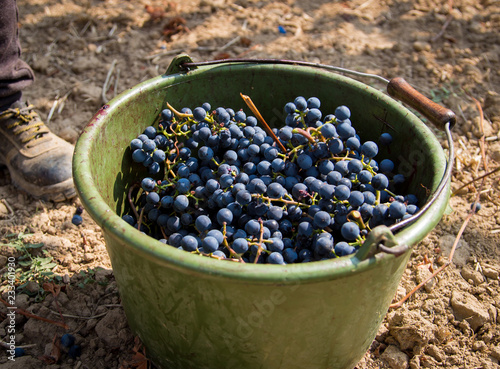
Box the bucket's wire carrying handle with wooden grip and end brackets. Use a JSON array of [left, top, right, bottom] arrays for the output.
[[165, 54, 456, 260]]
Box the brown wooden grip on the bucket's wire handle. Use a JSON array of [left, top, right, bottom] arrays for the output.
[[387, 77, 457, 130]]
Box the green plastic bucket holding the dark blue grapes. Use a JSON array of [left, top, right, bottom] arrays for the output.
[[73, 58, 449, 369]]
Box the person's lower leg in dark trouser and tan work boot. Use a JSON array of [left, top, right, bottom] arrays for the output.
[[0, 0, 76, 201]]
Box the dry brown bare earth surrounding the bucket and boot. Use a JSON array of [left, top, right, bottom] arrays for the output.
[[0, 0, 500, 369]]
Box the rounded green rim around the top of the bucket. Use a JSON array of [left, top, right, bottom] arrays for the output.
[[73, 62, 449, 284]]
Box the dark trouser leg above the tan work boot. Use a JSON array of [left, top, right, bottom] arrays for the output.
[[0, 0, 34, 108]]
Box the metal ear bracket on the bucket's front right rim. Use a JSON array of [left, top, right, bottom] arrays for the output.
[[356, 225, 409, 260]]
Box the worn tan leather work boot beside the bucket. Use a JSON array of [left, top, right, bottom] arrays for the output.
[[0, 102, 76, 201]]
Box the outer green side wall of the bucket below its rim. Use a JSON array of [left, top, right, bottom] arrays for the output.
[[106, 227, 407, 369]]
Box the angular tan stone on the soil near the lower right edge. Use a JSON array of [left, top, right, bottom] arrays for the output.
[[450, 291, 490, 331]]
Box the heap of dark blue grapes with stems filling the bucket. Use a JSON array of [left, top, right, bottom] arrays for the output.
[[123, 96, 418, 264]]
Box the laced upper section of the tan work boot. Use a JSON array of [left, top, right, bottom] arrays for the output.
[[0, 105, 49, 144]]
